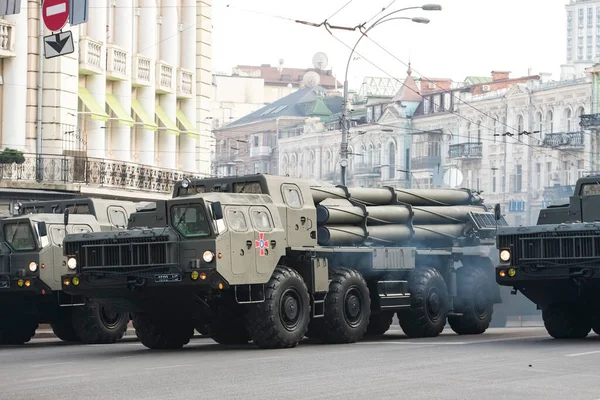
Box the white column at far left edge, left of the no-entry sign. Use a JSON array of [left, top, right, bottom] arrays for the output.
[[2, 1, 27, 151]]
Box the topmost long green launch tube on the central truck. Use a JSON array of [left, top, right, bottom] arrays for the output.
[[311, 186, 482, 206]]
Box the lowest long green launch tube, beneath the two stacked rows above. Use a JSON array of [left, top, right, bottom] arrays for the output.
[[317, 224, 465, 247]]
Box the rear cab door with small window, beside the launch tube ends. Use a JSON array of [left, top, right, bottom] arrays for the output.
[[281, 183, 317, 246]]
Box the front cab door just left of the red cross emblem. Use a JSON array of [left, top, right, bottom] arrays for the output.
[[225, 206, 256, 275]]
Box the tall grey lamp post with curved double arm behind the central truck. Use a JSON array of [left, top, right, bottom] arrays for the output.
[[340, 4, 442, 186]]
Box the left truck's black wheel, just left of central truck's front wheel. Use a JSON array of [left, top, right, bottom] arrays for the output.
[[72, 303, 129, 344]]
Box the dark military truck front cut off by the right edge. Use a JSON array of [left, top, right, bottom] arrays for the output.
[[496, 176, 600, 339]]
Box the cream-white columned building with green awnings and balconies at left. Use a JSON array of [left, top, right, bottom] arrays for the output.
[[0, 0, 212, 200]]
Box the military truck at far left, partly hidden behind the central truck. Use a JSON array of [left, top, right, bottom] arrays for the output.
[[0, 199, 145, 345]]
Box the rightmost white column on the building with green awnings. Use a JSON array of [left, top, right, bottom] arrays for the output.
[[179, 0, 198, 172]]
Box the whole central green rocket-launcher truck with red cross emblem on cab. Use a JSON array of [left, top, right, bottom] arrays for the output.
[[63, 174, 506, 349]]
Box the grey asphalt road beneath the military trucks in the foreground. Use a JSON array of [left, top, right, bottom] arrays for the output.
[[0, 327, 600, 400]]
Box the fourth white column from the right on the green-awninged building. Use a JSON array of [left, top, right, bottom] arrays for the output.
[[110, 0, 134, 161]]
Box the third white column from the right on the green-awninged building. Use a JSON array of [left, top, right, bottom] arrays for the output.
[[135, 0, 158, 165]]
